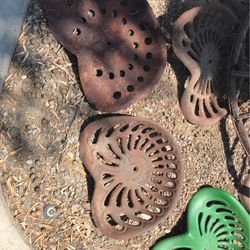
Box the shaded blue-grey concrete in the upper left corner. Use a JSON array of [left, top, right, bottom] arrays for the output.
[[0, 0, 29, 91]]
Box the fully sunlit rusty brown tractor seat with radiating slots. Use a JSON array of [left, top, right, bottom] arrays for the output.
[[80, 116, 183, 239]]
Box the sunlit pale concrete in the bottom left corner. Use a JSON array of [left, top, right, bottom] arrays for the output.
[[0, 186, 31, 250]]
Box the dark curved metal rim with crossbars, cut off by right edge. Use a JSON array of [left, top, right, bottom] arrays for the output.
[[228, 14, 250, 157]]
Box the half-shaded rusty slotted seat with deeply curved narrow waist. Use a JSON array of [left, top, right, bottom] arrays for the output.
[[172, 4, 238, 126]]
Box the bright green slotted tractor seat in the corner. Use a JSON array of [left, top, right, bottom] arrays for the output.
[[153, 187, 250, 250]]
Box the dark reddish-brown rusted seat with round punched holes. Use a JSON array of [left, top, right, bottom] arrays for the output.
[[43, 0, 167, 112]]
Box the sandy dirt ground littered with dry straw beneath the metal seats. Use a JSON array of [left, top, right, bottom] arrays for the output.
[[0, 0, 249, 250]]
